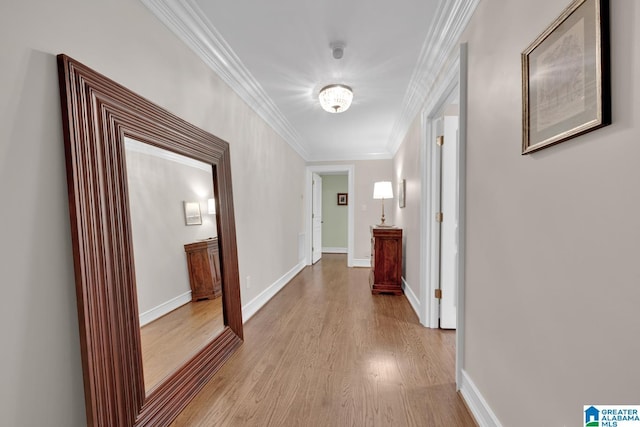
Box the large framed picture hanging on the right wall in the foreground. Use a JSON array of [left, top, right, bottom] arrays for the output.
[[522, 0, 611, 154]]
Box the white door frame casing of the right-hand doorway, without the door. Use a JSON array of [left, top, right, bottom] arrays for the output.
[[419, 43, 468, 389]]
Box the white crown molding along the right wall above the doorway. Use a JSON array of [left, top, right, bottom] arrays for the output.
[[388, 0, 480, 155]]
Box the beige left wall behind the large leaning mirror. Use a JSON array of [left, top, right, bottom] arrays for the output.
[[0, 0, 304, 426]]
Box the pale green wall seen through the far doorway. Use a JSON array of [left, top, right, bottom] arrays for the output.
[[322, 175, 349, 251]]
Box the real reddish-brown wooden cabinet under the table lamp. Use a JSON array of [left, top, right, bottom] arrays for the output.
[[369, 227, 403, 295]]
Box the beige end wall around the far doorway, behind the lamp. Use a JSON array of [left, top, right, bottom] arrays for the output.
[[307, 159, 398, 261]]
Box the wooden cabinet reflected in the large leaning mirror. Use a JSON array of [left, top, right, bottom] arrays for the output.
[[184, 237, 222, 301]]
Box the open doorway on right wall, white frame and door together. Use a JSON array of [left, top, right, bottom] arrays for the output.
[[420, 43, 467, 389]]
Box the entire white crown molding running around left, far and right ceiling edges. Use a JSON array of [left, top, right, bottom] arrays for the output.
[[140, 0, 480, 161]]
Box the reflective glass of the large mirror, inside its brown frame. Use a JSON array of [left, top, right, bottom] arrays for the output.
[[125, 138, 224, 395]]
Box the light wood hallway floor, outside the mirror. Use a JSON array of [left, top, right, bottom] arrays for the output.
[[173, 254, 476, 427]]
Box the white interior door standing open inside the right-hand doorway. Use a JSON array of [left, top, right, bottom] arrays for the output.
[[440, 115, 459, 329]]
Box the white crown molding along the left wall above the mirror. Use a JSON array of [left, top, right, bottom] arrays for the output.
[[140, 0, 309, 161]]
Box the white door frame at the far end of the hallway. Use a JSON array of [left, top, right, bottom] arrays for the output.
[[305, 165, 355, 267]]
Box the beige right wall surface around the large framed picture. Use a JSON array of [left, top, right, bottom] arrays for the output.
[[463, 0, 640, 427]]
